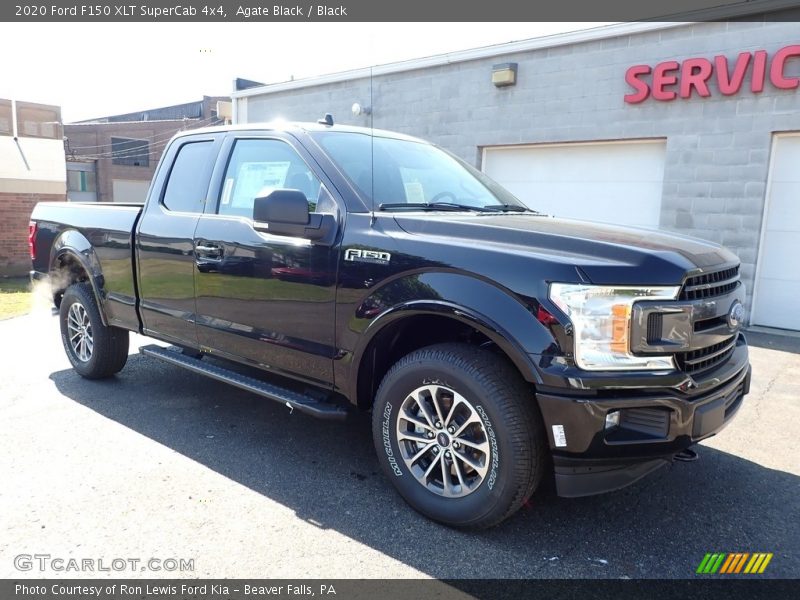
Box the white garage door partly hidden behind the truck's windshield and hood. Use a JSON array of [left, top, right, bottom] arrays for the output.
[[483, 140, 666, 228]]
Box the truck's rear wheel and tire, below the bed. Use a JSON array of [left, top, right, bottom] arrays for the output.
[[59, 282, 129, 379]]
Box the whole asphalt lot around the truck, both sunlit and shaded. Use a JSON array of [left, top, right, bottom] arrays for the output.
[[0, 307, 800, 579]]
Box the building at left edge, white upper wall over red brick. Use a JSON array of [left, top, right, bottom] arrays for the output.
[[0, 99, 66, 277]]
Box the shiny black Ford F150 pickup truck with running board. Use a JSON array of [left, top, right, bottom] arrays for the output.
[[30, 124, 750, 527]]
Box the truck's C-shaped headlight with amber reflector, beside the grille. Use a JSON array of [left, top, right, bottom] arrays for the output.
[[550, 283, 680, 371]]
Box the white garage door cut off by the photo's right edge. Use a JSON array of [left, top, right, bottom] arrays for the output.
[[750, 134, 800, 330]]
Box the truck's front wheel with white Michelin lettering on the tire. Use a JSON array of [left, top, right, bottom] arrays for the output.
[[372, 344, 547, 529]]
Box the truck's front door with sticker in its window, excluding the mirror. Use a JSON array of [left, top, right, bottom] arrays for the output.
[[194, 132, 342, 385]]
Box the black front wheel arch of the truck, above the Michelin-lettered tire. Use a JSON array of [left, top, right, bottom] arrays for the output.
[[343, 268, 557, 408]]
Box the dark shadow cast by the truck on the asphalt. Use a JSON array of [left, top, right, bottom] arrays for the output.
[[51, 355, 800, 579]]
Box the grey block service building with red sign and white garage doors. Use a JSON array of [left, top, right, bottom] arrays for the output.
[[232, 15, 800, 330]]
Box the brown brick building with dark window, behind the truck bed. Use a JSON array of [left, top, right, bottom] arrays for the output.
[[64, 96, 230, 202]]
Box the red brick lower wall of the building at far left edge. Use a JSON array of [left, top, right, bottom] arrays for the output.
[[0, 193, 67, 277]]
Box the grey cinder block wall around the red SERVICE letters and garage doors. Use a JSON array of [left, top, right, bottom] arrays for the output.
[[241, 21, 800, 316]]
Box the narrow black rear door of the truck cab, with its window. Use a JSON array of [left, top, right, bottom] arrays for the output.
[[136, 134, 223, 347]]
